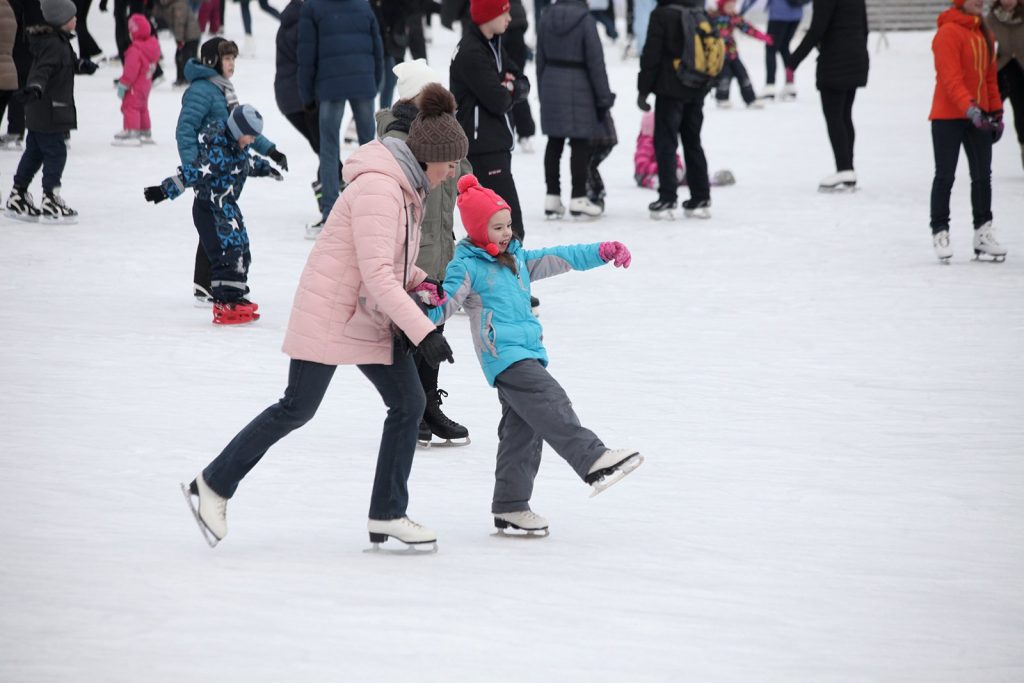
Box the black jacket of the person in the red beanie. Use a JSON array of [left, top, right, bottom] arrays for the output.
[[449, 24, 529, 157]]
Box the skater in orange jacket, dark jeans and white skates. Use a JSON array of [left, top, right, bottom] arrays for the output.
[[928, 0, 1007, 263]]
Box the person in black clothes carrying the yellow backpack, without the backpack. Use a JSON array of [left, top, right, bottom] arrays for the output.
[[637, 0, 711, 218]]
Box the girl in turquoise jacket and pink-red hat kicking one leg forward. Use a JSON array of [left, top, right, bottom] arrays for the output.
[[429, 175, 643, 536]]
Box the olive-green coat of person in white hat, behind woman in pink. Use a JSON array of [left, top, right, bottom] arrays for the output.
[[377, 102, 473, 280]]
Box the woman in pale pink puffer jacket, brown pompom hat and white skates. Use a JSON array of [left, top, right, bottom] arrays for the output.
[[182, 84, 469, 549]]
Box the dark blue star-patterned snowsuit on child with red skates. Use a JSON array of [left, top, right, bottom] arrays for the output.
[[160, 121, 281, 302]]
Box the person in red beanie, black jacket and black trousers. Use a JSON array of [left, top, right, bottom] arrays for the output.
[[449, 0, 529, 242]]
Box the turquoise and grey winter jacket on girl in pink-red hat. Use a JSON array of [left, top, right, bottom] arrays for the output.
[[427, 240, 604, 386]]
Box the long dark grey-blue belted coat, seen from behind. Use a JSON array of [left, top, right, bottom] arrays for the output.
[[537, 0, 615, 138]]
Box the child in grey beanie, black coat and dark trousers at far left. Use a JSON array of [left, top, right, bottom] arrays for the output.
[[7, 0, 96, 223]]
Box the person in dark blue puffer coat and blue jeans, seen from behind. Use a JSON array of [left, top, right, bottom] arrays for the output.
[[298, 0, 384, 227]]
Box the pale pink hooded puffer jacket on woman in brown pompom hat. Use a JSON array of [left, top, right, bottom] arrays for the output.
[[284, 140, 435, 366]]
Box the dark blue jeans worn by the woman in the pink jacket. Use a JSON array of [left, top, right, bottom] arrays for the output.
[[203, 354, 427, 519]]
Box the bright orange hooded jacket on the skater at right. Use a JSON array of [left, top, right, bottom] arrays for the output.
[[928, 7, 1002, 121]]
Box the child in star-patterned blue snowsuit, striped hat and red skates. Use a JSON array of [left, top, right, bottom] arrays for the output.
[[145, 104, 282, 325]]
